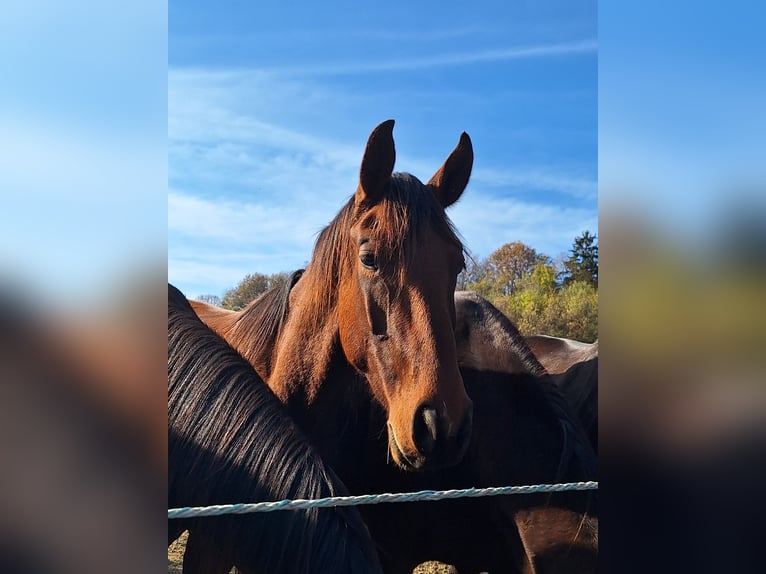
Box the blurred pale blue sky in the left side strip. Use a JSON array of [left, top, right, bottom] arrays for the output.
[[0, 0, 167, 308]]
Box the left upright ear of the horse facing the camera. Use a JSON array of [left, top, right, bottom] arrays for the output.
[[354, 120, 396, 205]]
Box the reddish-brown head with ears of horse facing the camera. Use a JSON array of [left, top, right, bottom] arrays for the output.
[[338, 120, 473, 469]]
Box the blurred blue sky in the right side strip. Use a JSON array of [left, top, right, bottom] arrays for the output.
[[598, 0, 766, 243]]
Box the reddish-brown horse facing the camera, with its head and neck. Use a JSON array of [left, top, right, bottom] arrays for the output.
[[195, 120, 473, 469]]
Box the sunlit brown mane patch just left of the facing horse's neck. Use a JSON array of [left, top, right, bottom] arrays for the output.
[[224, 269, 303, 377]]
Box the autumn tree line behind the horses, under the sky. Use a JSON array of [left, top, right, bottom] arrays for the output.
[[197, 231, 598, 342]]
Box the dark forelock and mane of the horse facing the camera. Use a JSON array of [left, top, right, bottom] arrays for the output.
[[304, 173, 464, 327]]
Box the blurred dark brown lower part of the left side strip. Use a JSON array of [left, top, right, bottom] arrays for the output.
[[0, 288, 167, 574]]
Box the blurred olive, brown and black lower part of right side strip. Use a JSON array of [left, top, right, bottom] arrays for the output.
[[599, 209, 766, 573]]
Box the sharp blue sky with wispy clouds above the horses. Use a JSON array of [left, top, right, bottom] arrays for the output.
[[168, 0, 598, 297]]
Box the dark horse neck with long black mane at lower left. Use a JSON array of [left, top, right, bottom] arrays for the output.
[[168, 285, 379, 572]]
